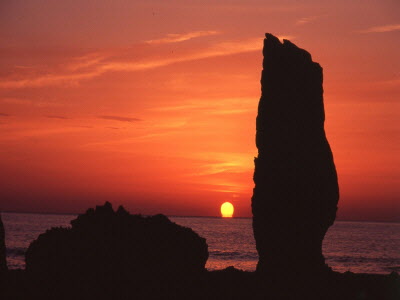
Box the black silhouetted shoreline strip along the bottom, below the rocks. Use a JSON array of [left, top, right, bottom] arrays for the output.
[[0, 267, 400, 300]]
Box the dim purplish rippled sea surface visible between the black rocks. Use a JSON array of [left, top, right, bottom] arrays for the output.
[[2, 213, 400, 274]]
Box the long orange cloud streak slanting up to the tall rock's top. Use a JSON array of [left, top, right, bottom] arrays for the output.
[[0, 38, 262, 89]]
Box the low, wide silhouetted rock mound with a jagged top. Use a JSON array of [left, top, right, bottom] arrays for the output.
[[26, 202, 208, 282]]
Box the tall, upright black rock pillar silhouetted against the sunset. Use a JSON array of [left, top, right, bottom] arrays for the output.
[[252, 34, 339, 276]]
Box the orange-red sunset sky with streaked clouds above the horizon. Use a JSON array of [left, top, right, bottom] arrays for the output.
[[0, 0, 400, 221]]
